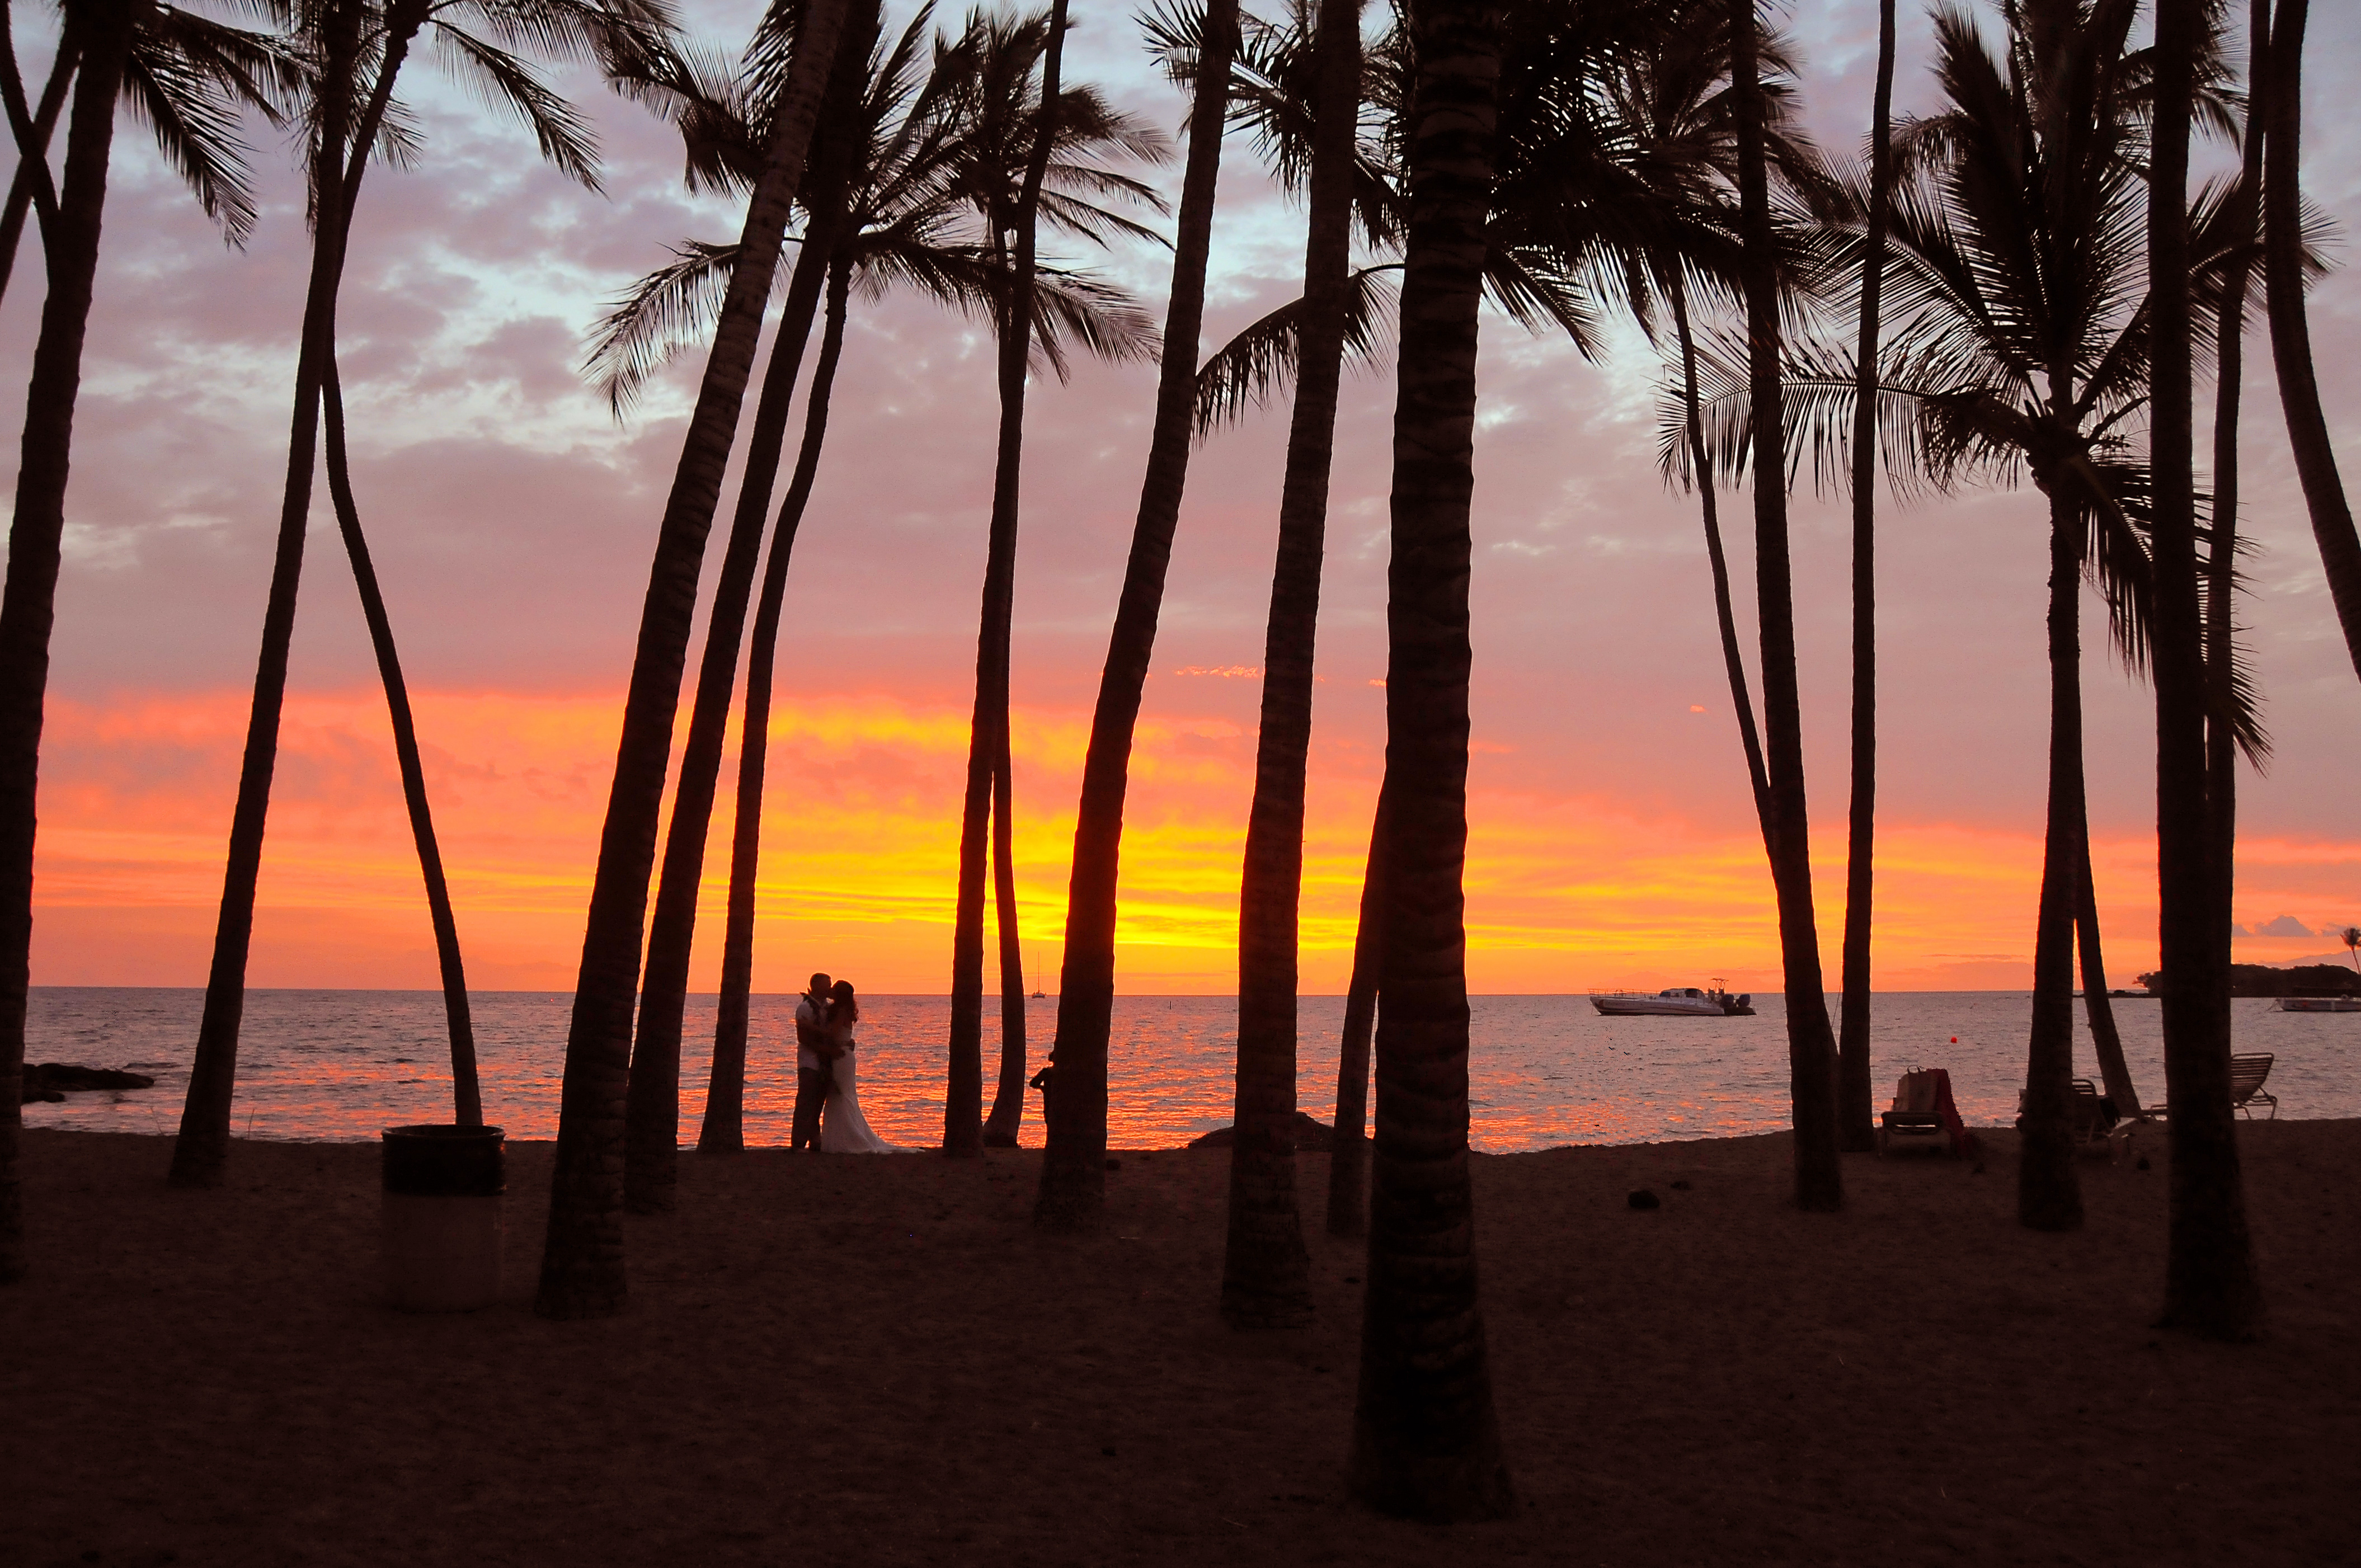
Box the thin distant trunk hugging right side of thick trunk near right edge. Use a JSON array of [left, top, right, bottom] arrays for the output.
[[2205, 0, 2271, 1029]]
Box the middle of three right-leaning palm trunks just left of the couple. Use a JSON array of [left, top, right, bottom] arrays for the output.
[[623, 21, 876, 1214]]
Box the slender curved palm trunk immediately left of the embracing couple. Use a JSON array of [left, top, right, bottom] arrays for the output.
[[697, 255, 852, 1155]]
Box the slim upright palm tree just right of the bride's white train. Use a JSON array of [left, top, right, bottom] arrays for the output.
[[942, 0, 1167, 1157]]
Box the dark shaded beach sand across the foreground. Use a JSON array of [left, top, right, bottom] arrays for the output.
[[0, 1122, 2361, 1566]]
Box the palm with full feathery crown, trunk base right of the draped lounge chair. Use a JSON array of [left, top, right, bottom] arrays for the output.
[[1714, 0, 2266, 1228]]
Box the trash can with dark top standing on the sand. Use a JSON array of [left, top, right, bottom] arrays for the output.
[[383, 1127, 507, 1313]]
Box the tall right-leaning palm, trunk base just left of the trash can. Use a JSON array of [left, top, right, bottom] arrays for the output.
[[170, 0, 668, 1188]]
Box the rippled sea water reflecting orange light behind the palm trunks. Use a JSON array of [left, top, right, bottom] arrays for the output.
[[23, 987, 2361, 1152]]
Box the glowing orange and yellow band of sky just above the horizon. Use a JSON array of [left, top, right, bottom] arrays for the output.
[[35, 687, 2361, 992]]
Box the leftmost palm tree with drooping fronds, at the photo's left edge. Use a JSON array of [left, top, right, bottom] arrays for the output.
[[0, 0, 281, 1282]]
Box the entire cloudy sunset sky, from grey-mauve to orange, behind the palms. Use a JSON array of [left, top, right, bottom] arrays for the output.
[[13, 0, 2361, 992]]
